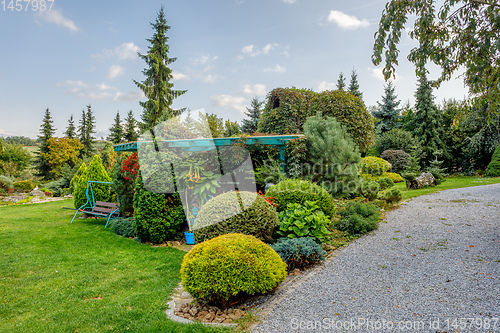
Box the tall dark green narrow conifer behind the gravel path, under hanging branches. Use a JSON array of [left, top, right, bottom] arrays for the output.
[[408, 76, 446, 168]]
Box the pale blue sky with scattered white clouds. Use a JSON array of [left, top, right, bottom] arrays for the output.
[[0, 0, 467, 138]]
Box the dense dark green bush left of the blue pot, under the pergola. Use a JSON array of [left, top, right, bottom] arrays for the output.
[[134, 173, 185, 244]]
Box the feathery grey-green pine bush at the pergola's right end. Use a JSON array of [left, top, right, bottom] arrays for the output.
[[304, 116, 361, 195]]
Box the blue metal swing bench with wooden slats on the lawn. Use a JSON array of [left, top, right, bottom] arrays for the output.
[[71, 180, 120, 228]]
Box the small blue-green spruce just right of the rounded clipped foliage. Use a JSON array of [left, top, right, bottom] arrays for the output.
[[372, 81, 401, 134]]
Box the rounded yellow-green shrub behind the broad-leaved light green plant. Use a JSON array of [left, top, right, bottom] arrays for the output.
[[266, 179, 335, 217]]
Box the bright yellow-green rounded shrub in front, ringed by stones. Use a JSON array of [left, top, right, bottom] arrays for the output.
[[181, 234, 286, 307]]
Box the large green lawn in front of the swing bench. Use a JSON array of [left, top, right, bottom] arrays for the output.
[[0, 200, 228, 332]]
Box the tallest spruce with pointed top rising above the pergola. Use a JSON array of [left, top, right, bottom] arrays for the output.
[[134, 6, 186, 131]]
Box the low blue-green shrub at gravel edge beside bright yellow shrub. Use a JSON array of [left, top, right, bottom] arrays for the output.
[[271, 237, 326, 272]]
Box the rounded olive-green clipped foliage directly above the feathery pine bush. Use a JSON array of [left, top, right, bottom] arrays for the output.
[[310, 90, 375, 153]]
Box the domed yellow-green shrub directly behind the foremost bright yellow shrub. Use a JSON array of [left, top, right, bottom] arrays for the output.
[[193, 191, 278, 242]]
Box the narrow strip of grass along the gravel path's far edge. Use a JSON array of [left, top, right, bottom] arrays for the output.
[[396, 176, 500, 199]]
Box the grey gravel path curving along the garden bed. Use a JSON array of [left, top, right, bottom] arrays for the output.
[[253, 184, 500, 333]]
